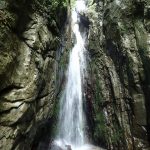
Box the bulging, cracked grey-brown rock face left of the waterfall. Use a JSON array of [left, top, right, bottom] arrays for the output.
[[0, 0, 65, 150]]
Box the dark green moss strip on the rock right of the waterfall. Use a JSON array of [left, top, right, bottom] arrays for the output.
[[89, 64, 107, 144]]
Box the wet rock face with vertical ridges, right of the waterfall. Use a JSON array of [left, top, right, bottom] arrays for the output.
[[87, 0, 150, 150]]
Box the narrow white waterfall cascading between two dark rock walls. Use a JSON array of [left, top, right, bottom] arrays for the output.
[[52, 0, 86, 149]]
